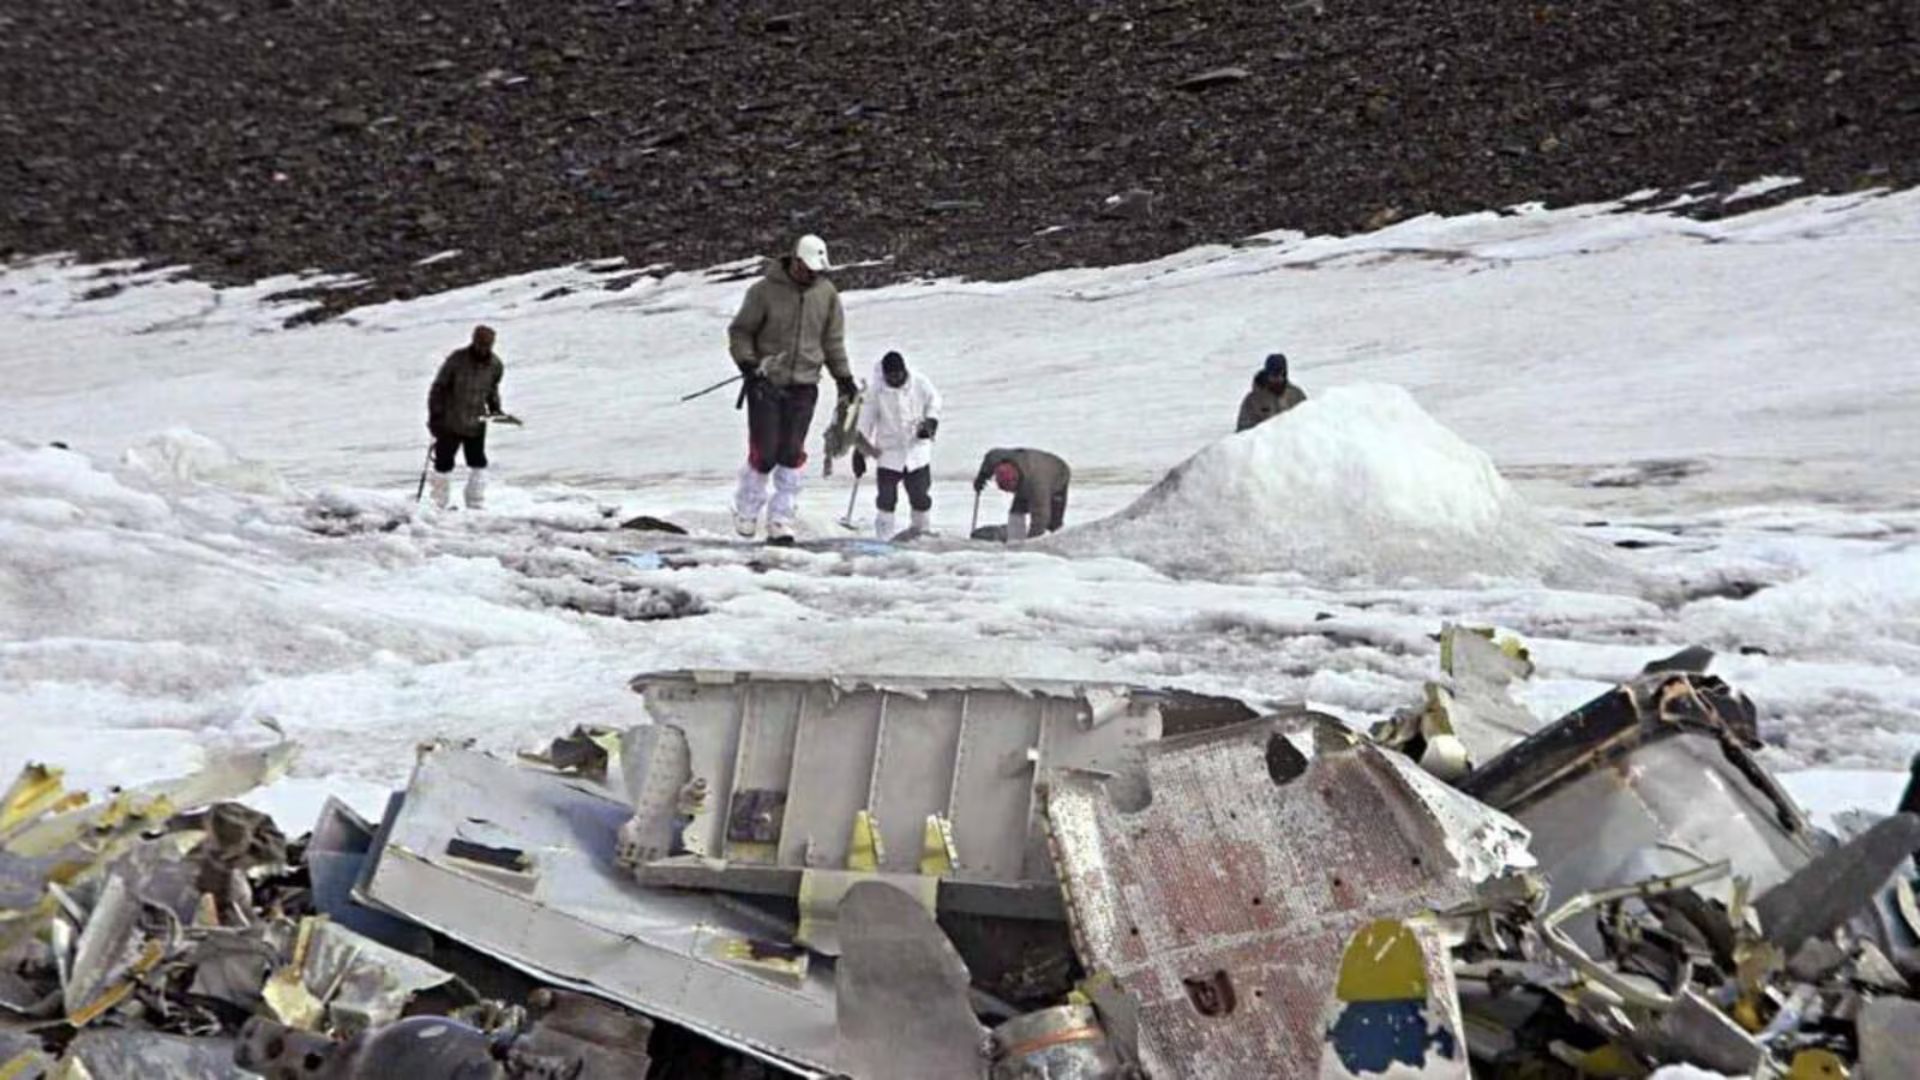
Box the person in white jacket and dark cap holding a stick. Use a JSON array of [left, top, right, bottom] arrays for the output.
[[852, 352, 941, 540]]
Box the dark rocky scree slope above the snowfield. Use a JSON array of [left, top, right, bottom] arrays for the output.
[[0, 0, 1920, 319]]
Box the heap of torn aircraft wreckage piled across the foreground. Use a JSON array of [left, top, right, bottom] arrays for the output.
[[0, 626, 1920, 1080]]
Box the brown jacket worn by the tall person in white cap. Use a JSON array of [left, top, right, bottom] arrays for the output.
[[726, 259, 852, 386]]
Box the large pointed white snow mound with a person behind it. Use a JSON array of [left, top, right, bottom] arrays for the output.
[[1056, 384, 1628, 584]]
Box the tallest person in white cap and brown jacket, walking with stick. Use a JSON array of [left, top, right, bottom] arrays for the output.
[[728, 236, 860, 542]]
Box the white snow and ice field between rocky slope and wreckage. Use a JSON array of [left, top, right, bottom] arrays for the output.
[[0, 192, 1920, 828]]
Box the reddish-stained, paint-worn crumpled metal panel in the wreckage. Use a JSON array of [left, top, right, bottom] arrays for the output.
[[1046, 723, 1530, 1076]]
